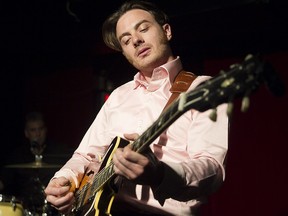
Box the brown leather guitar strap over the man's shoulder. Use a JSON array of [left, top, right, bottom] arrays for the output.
[[163, 70, 197, 111]]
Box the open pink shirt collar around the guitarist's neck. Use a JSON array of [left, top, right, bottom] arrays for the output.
[[134, 56, 182, 91]]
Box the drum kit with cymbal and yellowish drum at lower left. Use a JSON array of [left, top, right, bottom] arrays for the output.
[[0, 155, 61, 216]]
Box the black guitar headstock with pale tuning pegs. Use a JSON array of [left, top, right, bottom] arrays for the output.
[[179, 55, 264, 121]]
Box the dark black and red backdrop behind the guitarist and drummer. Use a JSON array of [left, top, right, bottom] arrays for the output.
[[0, 0, 288, 216]]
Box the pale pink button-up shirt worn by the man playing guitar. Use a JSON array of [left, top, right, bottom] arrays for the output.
[[55, 57, 228, 215]]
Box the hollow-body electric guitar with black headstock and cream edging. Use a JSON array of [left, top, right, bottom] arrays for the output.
[[68, 55, 276, 216]]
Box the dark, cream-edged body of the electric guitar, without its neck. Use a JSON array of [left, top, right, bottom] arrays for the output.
[[74, 137, 129, 216]]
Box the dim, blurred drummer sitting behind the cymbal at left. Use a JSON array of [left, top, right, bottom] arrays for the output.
[[2, 111, 72, 213]]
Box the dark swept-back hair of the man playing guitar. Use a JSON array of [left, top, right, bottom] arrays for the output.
[[102, 0, 169, 51]]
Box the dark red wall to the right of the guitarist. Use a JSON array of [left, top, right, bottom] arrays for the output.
[[203, 53, 288, 216]]
